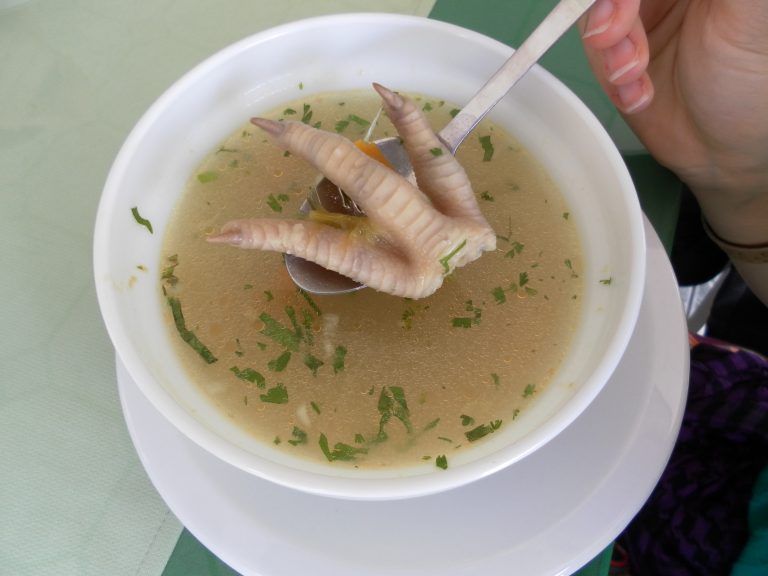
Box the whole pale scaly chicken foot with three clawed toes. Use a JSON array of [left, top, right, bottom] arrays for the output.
[[207, 84, 496, 299]]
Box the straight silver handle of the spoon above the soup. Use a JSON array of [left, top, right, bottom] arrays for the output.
[[438, 0, 595, 154]]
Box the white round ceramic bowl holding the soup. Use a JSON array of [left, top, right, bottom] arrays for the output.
[[94, 14, 645, 499]]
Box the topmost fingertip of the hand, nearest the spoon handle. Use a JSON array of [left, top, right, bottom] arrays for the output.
[[579, 0, 640, 50]]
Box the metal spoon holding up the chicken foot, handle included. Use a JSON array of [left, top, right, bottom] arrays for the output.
[[285, 0, 595, 295]]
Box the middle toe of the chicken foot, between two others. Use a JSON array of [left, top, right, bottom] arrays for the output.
[[252, 118, 449, 250]]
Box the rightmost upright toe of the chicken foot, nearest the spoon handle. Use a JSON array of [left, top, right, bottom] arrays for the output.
[[373, 83, 485, 222]]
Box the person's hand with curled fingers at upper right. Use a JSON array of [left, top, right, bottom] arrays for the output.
[[580, 0, 768, 244]]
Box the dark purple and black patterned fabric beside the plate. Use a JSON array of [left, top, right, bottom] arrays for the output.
[[619, 337, 768, 576]]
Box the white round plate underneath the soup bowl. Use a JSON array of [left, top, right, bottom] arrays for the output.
[[117, 218, 689, 576]]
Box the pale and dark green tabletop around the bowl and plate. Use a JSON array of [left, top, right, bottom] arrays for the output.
[[0, 0, 679, 576]]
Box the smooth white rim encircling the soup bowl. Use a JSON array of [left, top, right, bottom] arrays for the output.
[[93, 12, 645, 500]]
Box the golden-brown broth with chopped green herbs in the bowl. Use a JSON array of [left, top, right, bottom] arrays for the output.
[[161, 91, 582, 469]]
